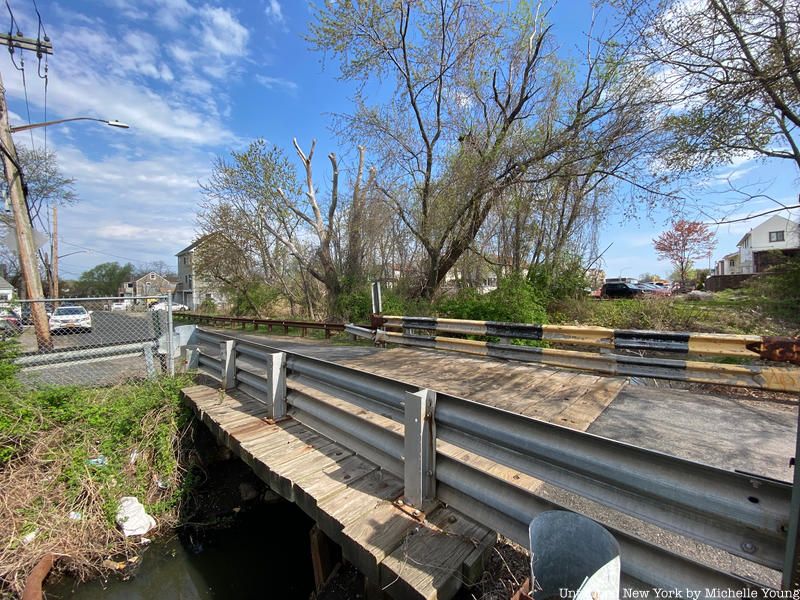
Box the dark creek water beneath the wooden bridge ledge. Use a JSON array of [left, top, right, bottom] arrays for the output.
[[45, 425, 314, 600]]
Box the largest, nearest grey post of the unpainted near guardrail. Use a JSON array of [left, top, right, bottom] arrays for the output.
[[403, 388, 436, 510]]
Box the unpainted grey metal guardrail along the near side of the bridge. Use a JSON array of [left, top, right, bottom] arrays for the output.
[[191, 331, 795, 597]]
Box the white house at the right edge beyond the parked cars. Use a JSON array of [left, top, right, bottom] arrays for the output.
[[715, 215, 800, 275]]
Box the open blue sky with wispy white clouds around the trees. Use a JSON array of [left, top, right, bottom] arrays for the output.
[[0, 0, 797, 278]]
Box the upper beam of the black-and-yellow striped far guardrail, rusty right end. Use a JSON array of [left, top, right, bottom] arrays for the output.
[[383, 316, 800, 364]]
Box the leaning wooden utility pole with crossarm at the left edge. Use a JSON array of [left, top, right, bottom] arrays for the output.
[[0, 36, 53, 350]]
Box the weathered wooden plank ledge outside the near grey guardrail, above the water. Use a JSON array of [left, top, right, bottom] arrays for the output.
[[183, 384, 496, 599]]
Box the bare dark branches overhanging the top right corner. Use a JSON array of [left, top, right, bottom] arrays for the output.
[[628, 0, 800, 169]]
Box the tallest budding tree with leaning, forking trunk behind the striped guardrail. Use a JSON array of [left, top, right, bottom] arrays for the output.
[[310, 0, 668, 298]]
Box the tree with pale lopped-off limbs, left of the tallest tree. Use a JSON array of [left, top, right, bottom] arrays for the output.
[[198, 140, 372, 316]]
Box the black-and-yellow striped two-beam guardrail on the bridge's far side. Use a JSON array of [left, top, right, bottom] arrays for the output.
[[352, 316, 800, 392]]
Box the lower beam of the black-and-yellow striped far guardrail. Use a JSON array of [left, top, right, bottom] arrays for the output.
[[375, 331, 800, 392]]
